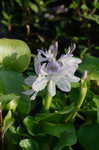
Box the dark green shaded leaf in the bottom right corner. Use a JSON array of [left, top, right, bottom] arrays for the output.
[[78, 124, 99, 150]]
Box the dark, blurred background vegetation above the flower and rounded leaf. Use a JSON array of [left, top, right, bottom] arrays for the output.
[[0, 0, 99, 56]]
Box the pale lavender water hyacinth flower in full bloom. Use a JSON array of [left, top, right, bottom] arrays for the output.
[[24, 42, 81, 99]]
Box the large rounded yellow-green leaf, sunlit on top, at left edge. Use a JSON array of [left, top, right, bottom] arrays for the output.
[[0, 38, 31, 72]]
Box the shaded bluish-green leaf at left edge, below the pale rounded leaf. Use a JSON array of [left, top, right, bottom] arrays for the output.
[[0, 71, 24, 94]]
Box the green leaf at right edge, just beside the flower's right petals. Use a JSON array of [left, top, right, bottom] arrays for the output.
[[79, 55, 99, 80]]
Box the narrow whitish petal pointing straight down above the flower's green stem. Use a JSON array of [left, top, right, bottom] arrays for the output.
[[48, 80, 56, 97]]
